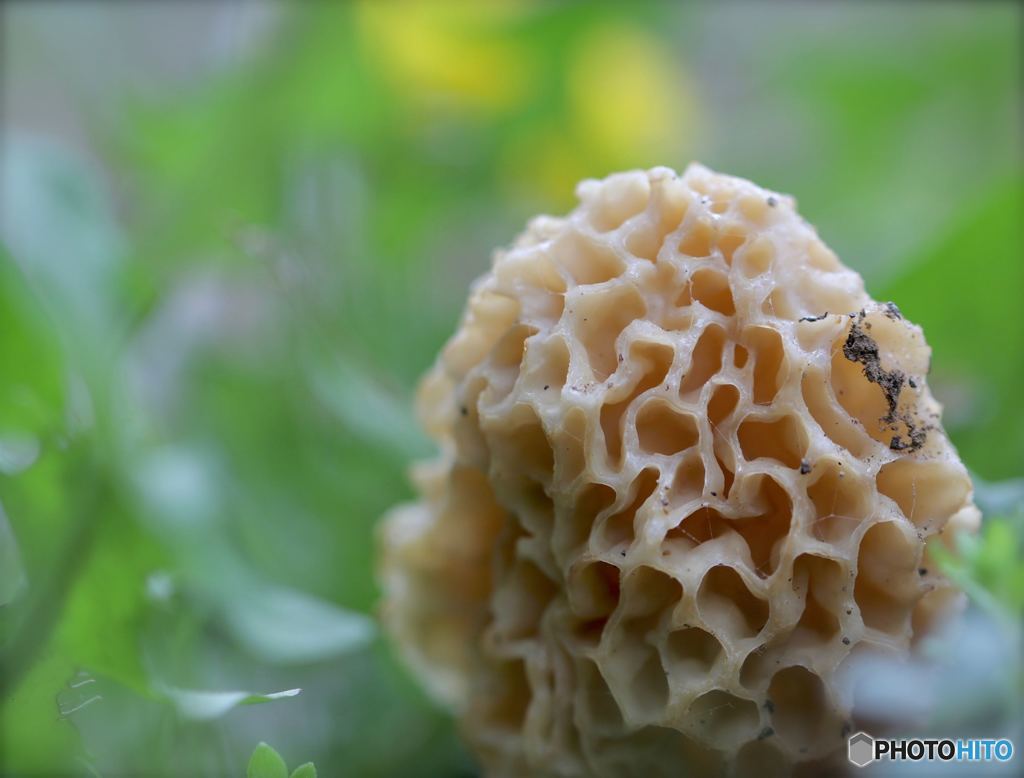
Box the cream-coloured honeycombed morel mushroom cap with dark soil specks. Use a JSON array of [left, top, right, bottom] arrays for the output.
[[381, 165, 979, 778]]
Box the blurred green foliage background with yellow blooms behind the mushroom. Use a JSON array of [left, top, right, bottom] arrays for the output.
[[0, 0, 1024, 777]]
